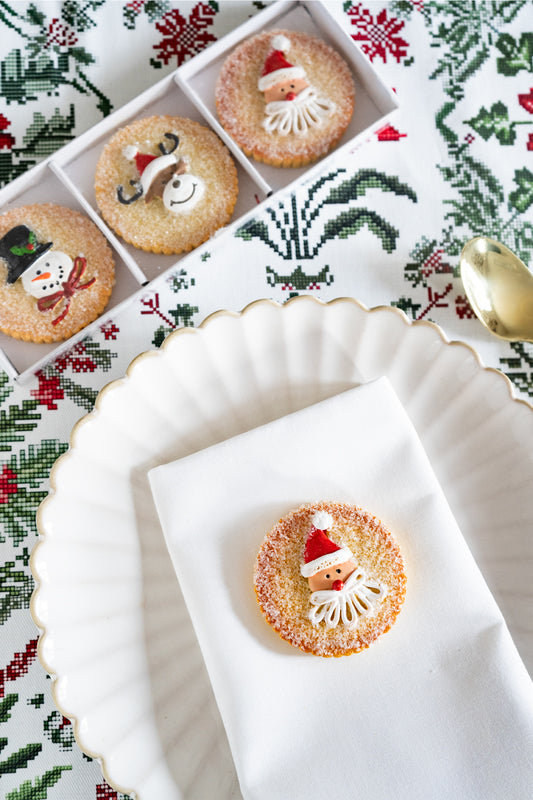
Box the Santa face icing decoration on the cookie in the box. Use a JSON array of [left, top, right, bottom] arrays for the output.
[[257, 36, 335, 136]]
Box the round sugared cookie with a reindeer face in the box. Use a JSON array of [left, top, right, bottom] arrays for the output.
[[95, 116, 238, 254]]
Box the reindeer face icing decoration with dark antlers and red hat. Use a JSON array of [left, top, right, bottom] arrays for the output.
[[117, 133, 205, 214]]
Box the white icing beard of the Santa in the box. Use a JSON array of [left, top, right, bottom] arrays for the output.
[[263, 86, 335, 136]]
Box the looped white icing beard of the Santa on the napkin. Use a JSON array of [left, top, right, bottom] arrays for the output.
[[309, 569, 386, 628]]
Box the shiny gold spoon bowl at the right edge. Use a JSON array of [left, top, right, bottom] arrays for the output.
[[461, 236, 533, 342]]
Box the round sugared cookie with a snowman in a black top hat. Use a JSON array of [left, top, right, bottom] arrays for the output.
[[0, 203, 115, 342]]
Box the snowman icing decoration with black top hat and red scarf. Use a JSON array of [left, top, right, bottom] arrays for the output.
[[0, 225, 96, 325]]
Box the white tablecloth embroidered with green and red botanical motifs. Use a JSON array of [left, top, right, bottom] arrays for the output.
[[0, 0, 533, 800]]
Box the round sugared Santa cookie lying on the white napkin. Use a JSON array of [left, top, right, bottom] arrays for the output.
[[254, 503, 406, 656]]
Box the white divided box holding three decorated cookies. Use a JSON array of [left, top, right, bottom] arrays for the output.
[[0, 0, 398, 379]]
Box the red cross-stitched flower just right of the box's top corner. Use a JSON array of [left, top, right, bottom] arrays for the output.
[[346, 3, 409, 64]]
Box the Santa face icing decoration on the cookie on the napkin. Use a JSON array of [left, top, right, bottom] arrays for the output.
[[300, 511, 386, 628]]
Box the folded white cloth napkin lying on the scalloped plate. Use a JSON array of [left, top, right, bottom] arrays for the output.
[[150, 379, 533, 800]]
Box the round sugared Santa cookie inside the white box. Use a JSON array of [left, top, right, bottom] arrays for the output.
[[215, 30, 355, 167]]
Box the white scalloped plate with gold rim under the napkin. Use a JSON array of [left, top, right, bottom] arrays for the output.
[[32, 297, 533, 800]]
